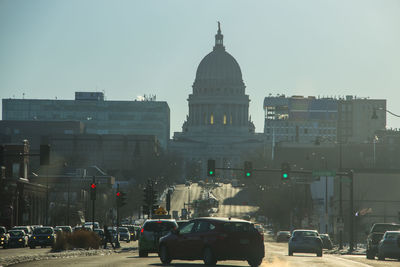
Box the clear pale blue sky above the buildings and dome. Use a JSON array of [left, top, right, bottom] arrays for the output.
[[0, 0, 400, 135]]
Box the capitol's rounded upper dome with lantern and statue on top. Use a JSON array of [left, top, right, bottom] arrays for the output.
[[193, 25, 244, 91]]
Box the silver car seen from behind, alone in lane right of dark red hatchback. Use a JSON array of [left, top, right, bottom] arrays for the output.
[[288, 229, 322, 257]]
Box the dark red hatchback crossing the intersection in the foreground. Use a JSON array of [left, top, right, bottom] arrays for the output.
[[159, 217, 265, 267]]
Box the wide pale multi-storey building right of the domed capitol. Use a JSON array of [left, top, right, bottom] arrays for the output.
[[264, 95, 386, 144]]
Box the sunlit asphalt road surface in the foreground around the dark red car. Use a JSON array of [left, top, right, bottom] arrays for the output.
[[12, 241, 400, 267]]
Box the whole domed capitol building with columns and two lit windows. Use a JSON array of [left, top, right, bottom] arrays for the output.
[[169, 23, 263, 178]]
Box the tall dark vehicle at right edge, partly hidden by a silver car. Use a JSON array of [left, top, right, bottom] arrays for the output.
[[366, 223, 400, 259]]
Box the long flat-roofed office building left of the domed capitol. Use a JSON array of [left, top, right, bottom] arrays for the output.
[[3, 92, 170, 149]]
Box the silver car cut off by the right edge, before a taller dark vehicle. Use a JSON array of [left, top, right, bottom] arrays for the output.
[[378, 231, 400, 260]]
